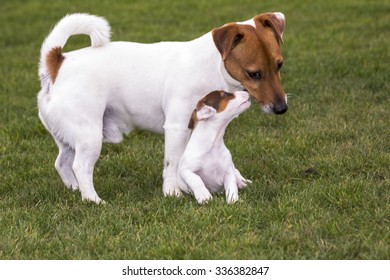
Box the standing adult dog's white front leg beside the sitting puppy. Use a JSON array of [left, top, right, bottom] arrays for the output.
[[163, 125, 190, 196]]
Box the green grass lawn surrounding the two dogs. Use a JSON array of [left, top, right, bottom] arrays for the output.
[[0, 0, 390, 259]]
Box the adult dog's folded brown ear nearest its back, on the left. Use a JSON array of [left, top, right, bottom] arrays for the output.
[[212, 24, 244, 60]]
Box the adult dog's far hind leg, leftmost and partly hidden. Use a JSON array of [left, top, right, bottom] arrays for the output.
[[54, 140, 78, 191]]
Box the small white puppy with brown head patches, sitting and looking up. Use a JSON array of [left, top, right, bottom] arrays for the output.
[[178, 91, 251, 204]]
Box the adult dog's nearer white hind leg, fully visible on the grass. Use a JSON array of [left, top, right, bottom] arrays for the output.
[[72, 128, 104, 204]]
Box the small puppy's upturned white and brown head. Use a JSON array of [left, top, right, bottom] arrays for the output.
[[188, 90, 251, 129]]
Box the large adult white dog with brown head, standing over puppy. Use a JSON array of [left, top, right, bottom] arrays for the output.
[[38, 13, 287, 203]]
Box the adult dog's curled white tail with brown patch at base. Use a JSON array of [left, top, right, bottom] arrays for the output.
[[39, 14, 110, 86]]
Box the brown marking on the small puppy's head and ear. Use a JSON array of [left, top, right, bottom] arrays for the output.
[[188, 90, 235, 129]]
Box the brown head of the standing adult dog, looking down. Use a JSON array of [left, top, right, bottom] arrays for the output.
[[212, 13, 287, 114]]
